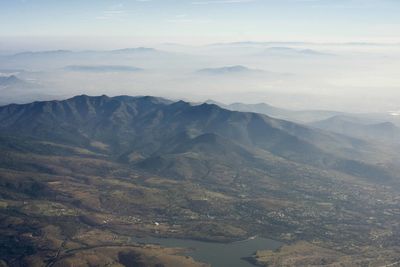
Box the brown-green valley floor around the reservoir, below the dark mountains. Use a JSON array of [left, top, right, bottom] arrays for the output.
[[0, 146, 400, 267]]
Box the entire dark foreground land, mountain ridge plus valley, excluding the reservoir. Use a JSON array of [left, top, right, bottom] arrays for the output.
[[0, 95, 400, 266]]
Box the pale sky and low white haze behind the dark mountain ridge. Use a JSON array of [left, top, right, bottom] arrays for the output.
[[0, 0, 400, 112]]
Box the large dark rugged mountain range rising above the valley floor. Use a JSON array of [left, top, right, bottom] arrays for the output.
[[0, 95, 391, 184]]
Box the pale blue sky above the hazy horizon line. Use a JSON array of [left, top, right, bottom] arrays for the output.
[[0, 0, 400, 48]]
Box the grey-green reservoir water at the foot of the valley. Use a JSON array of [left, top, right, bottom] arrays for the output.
[[132, 237, 283, 267]]
